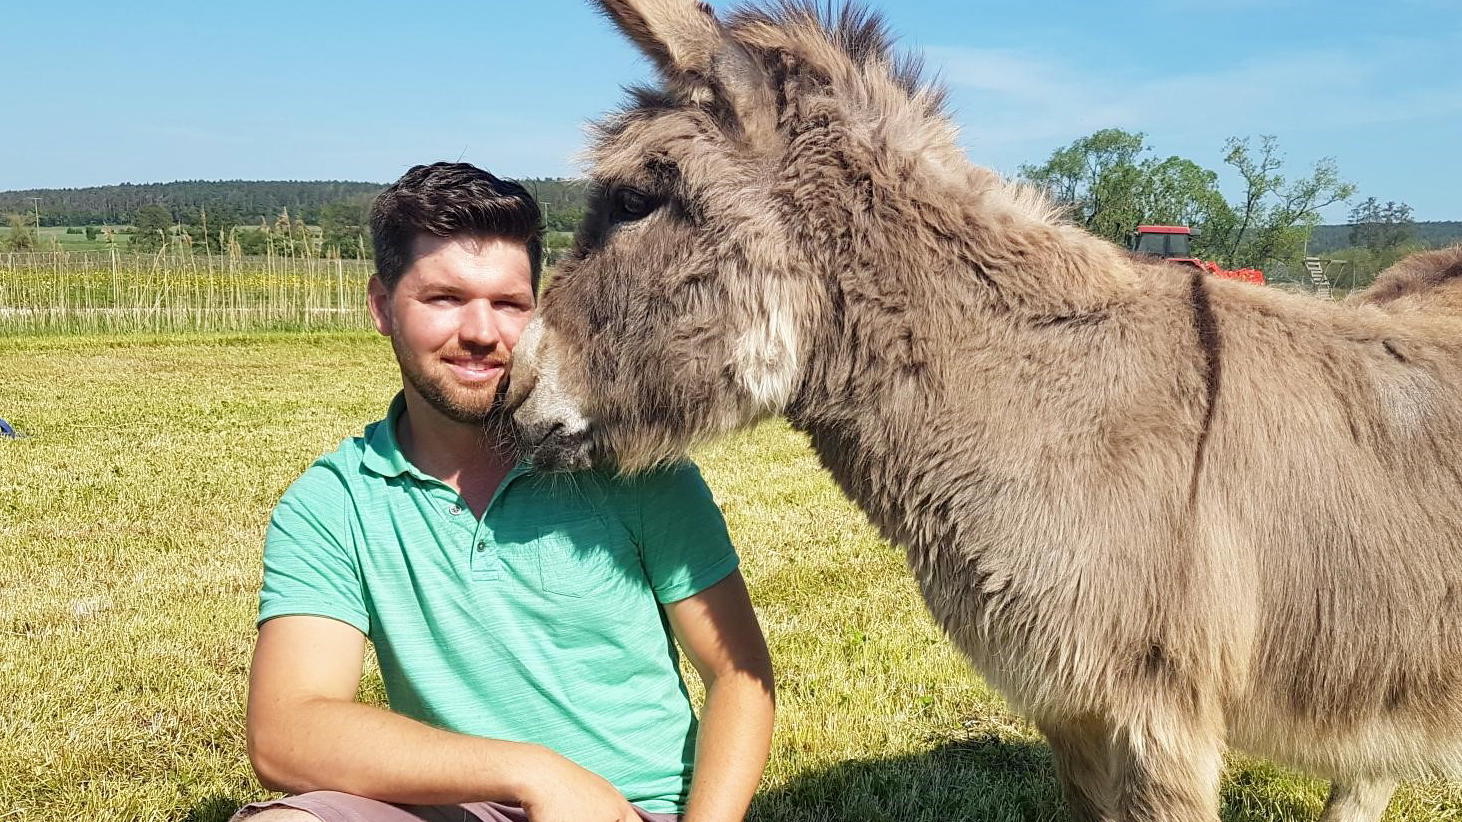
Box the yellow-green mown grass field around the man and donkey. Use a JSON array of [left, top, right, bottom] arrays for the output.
[[0, 333, 1462, 822]]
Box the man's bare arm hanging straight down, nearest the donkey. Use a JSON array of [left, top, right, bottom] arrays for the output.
[[665, 570, 775, 822]]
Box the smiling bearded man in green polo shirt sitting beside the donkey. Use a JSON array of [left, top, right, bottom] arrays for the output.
[[240, 162, 772, 822]]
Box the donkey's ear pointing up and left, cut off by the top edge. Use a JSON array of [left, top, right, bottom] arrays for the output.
[[595, 0, 725, 83]]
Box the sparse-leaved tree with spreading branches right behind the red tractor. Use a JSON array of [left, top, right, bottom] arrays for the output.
[[1213, 136, 1355, 268]]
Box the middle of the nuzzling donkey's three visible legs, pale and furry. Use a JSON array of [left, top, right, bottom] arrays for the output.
[[1113, 702, 1224, 822]]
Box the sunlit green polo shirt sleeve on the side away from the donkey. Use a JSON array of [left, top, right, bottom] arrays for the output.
[[257, 462, 370, 635]]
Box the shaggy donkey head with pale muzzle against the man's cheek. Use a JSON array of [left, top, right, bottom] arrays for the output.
[[509, 0, 969, 471]]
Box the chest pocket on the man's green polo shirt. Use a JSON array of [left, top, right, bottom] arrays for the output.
[[535, 515, 645, 597]]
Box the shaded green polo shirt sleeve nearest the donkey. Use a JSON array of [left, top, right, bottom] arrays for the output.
[[637, 462, 741, 603]]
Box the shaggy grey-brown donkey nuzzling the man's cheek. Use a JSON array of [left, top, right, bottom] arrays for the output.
[[507, 0, 1462, 822]]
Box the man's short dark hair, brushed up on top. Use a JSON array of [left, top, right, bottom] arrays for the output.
[[370, 162, 544, 294]]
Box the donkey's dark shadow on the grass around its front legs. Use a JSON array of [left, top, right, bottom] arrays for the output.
[[747, 734, 1319, 822]]
